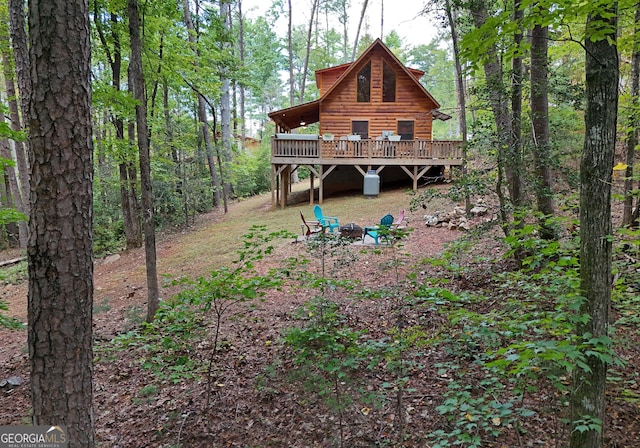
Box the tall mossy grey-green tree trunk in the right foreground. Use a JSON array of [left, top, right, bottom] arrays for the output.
[[570, 5, 618, 448]]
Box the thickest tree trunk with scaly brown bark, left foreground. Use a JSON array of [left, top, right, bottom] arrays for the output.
[[27, 0, 95, 448]]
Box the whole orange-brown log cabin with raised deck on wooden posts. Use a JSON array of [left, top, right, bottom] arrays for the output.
[[269, 39, 462, 209]]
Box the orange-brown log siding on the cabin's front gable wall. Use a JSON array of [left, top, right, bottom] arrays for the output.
[[320, 51, 436, 140]]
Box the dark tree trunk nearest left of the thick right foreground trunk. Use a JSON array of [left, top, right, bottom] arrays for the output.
[[531, 21, 556, 239]]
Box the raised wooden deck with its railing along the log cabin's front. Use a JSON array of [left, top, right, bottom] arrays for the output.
[[271, 136, 462, 166]]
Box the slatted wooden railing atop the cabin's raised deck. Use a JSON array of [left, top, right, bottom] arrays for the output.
[[271, 137, 462, 161]]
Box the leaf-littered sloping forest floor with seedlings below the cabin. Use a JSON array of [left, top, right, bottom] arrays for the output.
[[0, 184, 640, 448]]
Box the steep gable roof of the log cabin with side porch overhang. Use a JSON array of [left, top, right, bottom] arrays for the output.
[[268, 38, 451, 130]]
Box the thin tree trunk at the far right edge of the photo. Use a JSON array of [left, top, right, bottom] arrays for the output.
[[622, 2, 640, 226]]
